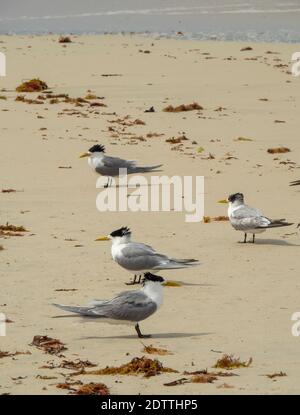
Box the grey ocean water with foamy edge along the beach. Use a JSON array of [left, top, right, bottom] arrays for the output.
[[0, 0, 300, 43]]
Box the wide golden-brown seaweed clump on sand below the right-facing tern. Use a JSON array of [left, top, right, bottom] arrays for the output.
[[83, 356, 178, 378]]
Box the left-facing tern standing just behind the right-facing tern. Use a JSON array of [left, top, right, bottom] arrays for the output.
[[96, 227, 198, 285]]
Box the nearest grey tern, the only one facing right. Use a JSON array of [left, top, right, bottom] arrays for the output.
[[53, 272, 164, 338]]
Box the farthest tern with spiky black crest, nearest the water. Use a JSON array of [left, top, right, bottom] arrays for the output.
[[79, 144, 162, 187]]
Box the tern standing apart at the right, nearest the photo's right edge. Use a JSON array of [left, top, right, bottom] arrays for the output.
[[219, 193, 293, 243]]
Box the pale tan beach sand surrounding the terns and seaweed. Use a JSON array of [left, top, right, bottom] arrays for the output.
[[0, 36, 300, 394]]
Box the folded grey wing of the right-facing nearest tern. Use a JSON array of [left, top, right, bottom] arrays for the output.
[[94, 290, 157, 322]]
